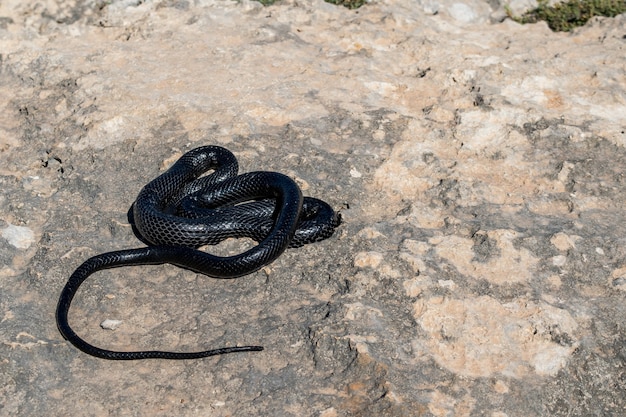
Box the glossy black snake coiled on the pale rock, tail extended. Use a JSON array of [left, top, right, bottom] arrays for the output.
[[56, 146, 341, 360]]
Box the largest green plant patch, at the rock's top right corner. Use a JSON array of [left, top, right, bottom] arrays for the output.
[[507, 0, 626, 32]]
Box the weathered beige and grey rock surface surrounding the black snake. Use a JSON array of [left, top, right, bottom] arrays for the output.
[[0, 0, 626, 417]]
